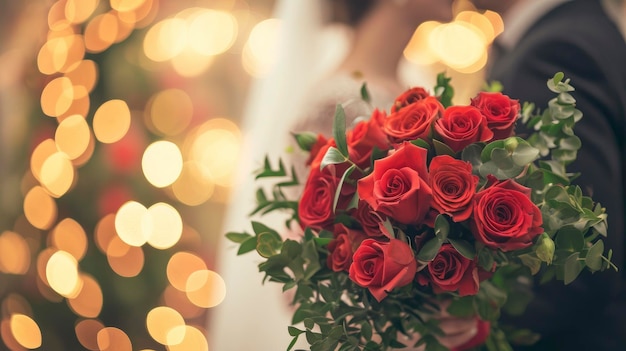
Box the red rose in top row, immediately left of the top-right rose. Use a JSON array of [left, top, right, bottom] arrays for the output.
[[435, 106, 493, 152]]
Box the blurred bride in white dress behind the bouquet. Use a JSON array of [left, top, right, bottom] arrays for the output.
[[208, 0, 452, 351]]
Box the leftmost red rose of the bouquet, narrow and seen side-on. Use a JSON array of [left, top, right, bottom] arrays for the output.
[[298, 166, 338, 229]]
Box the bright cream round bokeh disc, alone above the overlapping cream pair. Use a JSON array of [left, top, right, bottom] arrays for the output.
[[141, 140, 183, 188]]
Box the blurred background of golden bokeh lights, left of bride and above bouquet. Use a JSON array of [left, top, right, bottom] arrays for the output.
[[0, 0, 502, 351]]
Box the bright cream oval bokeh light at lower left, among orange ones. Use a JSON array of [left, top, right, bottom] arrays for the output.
[[46, 251, 83, 298]]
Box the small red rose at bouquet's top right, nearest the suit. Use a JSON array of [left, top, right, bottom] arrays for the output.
[[471, 92, 521, 140]]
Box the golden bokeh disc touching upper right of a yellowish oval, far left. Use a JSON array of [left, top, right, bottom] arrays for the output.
[[54, 115, 91, 160]]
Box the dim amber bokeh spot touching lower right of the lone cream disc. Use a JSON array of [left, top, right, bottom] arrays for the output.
[[172, 160, 215, 206]]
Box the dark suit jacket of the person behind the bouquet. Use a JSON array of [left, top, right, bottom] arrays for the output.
[[488, 0, 626, 351]]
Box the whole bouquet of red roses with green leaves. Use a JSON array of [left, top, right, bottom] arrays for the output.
[[227, 73, 616, 351]]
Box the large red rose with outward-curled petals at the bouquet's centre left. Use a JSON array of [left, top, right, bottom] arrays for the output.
[[357, 142, 432, 224]]
